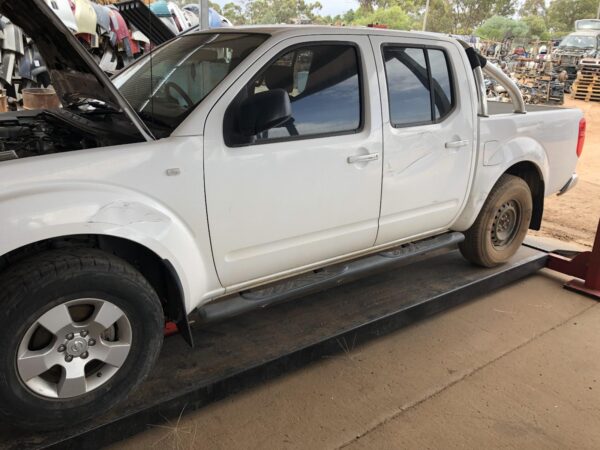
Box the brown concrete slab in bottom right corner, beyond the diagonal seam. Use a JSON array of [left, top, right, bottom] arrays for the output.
[[347, 278, 600, 449]]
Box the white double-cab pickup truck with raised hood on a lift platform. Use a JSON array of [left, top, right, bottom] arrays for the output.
[[0, 0, 585, 428]]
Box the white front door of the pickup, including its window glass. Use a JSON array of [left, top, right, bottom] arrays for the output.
[[204, 36, 383, 288]]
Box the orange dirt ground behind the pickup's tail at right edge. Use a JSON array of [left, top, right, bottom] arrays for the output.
[[532, 97, 600, 246]]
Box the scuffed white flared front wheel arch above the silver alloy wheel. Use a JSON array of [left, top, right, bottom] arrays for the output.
[[0, 183, 221, 312]]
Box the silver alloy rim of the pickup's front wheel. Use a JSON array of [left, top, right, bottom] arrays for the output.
[[17, 298, 132, 399]]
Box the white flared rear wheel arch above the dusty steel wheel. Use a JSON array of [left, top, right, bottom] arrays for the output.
[[452, 137, 550, 231]]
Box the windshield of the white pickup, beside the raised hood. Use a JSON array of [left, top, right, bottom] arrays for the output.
[[112, 33, 268, 136]]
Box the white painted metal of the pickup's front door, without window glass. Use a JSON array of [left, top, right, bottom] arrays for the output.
[[204, 35, 382, 288]]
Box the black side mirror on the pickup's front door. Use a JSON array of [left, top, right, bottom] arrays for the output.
[[240, 89, 292, 137]]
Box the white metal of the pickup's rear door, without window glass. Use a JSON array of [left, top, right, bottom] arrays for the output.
[[371, 36, 476, 245]]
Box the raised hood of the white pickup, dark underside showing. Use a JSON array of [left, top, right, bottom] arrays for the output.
[[0, 0, 154, 140]]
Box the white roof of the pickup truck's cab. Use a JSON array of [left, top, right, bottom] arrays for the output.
[[188, 25, 455, 42]]
